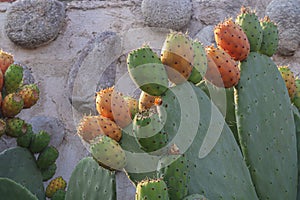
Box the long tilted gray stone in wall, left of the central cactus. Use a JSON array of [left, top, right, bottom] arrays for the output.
[[68, 32, 122, 114]]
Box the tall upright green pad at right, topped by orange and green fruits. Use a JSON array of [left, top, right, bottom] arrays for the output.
[[236, 52, 297, 199]]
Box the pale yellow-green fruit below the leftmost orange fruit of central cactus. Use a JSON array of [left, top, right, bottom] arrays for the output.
[[90, 135, 127, 170]]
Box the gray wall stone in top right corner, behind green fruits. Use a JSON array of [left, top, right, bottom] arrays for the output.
[[266, 0, 300, 56]]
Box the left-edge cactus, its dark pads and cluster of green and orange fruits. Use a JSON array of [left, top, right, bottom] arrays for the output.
[[0, 50, 63, 199]]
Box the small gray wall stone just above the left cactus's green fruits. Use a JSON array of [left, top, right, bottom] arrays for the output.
[[28, 116, 65, 148]]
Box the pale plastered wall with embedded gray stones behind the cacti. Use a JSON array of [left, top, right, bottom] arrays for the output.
[[0, 0, 300, 199]]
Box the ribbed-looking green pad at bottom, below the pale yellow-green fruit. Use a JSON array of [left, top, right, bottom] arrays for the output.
[[66, 157, 116, 200]]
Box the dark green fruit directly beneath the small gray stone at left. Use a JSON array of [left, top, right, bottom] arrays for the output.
[[29, 131, 50, 153]]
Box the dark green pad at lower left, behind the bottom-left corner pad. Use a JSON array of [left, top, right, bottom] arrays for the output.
[[0, 147, 46, 200]]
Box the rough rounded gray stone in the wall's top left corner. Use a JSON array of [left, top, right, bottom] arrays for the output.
[[5, 0, 65, 48]]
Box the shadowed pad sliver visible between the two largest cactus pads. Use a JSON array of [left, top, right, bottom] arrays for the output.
[[197, 81, 239, 141]]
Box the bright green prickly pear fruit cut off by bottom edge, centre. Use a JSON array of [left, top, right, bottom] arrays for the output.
[[135, 179, 169, 200]]
